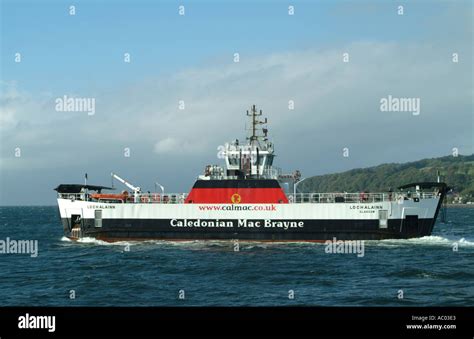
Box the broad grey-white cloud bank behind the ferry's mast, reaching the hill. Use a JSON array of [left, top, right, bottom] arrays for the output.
[[0, 36, 473, 205]]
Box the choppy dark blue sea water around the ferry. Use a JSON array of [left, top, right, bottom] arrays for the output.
[[0, 206, 474, 306]]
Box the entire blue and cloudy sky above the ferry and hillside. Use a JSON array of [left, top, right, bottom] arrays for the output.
[[0, 0, 474, 205]]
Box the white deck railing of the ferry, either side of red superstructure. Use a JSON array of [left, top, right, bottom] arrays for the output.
[[58, 192, 437, 204]]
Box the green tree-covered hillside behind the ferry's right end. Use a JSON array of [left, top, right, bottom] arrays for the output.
[[298, 155, 474, 201]]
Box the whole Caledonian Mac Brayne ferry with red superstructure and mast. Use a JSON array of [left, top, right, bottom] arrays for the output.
[[55, 105, 447, 242]]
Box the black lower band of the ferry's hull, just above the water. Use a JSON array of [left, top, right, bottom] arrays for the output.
[[62, 218, 436, 242]]
